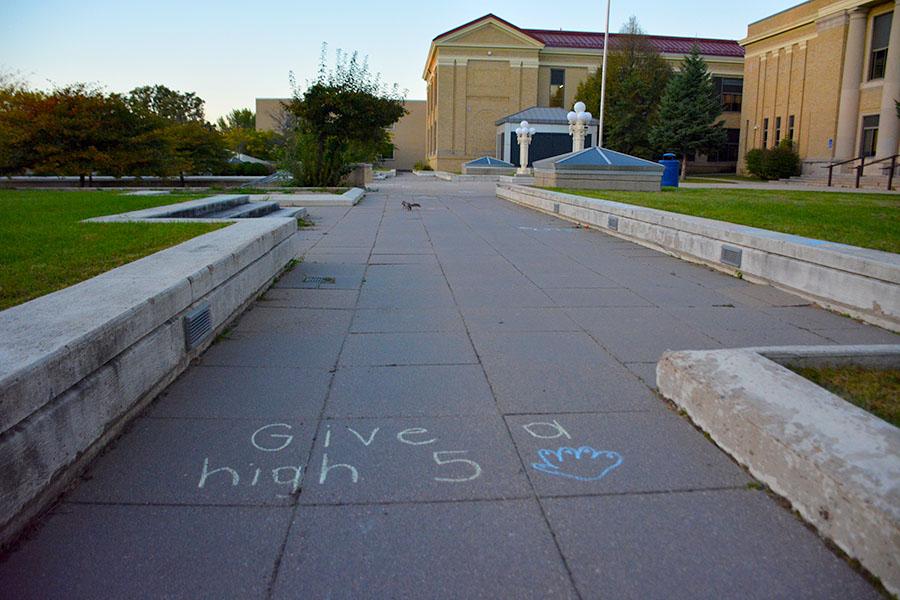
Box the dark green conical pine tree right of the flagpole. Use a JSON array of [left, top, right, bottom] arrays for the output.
[[650, 45, 726, 180]]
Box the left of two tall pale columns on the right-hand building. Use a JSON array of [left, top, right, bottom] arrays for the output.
[[834, 8, 868, 160]]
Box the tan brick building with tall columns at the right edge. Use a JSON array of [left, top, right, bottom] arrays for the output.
[[739, 0, 900, 174]]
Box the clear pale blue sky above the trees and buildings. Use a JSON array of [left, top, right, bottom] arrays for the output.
[[0, 0, 796, 119]]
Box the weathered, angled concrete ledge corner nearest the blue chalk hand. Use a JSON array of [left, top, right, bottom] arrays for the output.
[[656, 345, 900, 594]]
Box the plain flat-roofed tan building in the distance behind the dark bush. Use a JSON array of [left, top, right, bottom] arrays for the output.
[[256, 98, 425, 171]]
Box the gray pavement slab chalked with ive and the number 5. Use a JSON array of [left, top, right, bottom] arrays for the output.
[[300, 415, 531, 504]]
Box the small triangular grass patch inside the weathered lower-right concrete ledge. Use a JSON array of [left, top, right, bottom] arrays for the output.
[[793, 367, 900, 427]]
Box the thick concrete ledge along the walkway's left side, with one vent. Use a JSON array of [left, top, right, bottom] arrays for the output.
[[0, 218, 298, 545]]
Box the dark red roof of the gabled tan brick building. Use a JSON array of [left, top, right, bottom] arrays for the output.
[[434, 14, 744, 58]]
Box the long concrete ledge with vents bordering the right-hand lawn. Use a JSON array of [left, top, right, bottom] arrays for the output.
[[497, 183, 900, 331]]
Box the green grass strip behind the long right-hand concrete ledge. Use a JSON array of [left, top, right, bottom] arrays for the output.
[[553, 188, 900, 252]]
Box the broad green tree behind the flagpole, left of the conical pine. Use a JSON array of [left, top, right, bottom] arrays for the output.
[[577, 17, 672, 158]]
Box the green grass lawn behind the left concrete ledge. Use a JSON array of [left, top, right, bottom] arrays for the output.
[[0, 190, 225, 310]]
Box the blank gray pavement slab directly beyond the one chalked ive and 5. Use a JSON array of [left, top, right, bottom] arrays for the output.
[[325, 365, 497, 418]]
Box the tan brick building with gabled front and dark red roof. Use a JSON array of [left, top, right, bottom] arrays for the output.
[[422, 15, 744, 171]]
